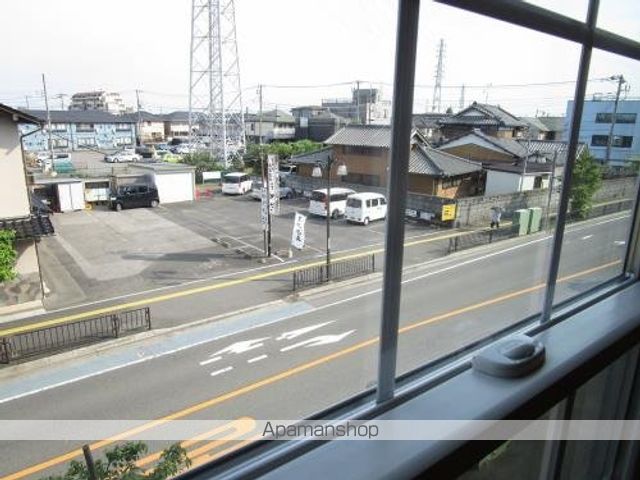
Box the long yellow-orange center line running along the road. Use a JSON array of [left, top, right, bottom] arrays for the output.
[[0, 260, 622, 480]]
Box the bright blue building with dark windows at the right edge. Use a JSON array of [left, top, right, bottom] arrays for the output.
[[564, 99, 640, 167]]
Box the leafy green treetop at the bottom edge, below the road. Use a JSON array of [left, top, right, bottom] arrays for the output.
[[46, 442, 191, 480]]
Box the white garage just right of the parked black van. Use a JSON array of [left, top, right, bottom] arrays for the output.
[[135, 163, 195, 203]]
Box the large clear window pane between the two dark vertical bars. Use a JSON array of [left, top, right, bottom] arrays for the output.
[[396, 8, 582, 375]]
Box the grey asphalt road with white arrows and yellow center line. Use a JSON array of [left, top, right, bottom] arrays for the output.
[[0, 216, 628, 479]]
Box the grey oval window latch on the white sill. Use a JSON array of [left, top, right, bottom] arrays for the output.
[[471, 335, 545, 378]]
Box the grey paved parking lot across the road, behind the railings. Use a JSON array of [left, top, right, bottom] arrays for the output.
[[40, 194, 440, 308]]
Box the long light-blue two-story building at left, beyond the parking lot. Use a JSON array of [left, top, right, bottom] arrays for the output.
[[20, 110, 136, 151]]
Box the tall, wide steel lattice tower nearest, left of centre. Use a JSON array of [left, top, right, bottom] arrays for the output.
[[189, 0, 245, 166]]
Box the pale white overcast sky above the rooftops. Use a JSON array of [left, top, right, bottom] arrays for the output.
[[0, 0, 640, 116]]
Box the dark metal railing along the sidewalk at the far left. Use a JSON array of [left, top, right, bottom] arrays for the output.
[[0, 307, 151, 363]]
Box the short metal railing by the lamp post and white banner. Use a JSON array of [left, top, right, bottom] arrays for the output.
[[293, 254, 376, 291]]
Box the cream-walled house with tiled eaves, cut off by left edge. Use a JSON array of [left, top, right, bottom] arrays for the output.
[[0, 104, 53, 314]]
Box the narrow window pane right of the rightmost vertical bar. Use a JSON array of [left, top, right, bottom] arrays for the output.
[[555, 47, 640, 303]]
